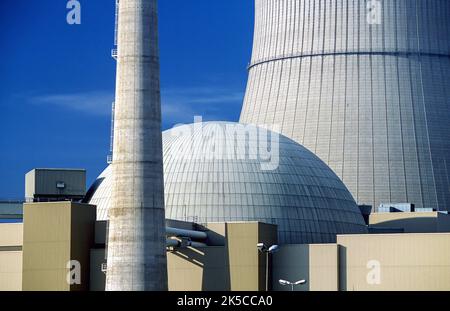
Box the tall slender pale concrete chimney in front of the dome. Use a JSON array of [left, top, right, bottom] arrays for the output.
[[106, 0, 167, 291]]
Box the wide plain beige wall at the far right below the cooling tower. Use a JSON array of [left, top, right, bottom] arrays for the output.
[[337, 233, 450, 291]]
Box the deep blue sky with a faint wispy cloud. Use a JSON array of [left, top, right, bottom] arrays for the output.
[[0, 0, 253, 199]]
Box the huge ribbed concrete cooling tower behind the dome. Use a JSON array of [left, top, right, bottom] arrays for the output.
[[241, 0, 450, 210]]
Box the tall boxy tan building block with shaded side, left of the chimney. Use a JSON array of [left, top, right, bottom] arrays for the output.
[[22, 202, 96, 291]]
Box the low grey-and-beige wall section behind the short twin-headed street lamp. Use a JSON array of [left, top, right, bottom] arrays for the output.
[[273, 244, 339, 291]]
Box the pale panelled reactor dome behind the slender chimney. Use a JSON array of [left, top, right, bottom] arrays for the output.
[[87, 122, 366, 244]]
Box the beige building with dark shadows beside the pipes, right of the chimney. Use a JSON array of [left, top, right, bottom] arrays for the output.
[[163, 222, 277, 291]]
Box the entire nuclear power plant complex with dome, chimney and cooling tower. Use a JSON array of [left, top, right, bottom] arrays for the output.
[[0, 0, 450, 291]]
